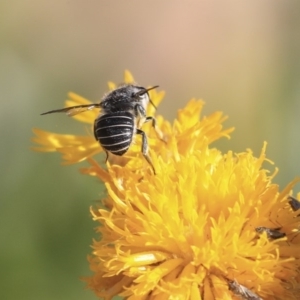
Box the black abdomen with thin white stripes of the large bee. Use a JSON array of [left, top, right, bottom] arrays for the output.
[[94, 111, 135, 155]]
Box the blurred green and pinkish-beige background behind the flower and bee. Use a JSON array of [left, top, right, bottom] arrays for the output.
[[0, 0, 300, 300]]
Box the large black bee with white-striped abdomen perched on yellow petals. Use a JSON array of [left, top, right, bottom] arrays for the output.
[[42, 84, 163, 174]]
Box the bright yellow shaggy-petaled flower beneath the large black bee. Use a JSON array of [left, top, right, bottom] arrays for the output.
[[35, 73, 300, 300]]
